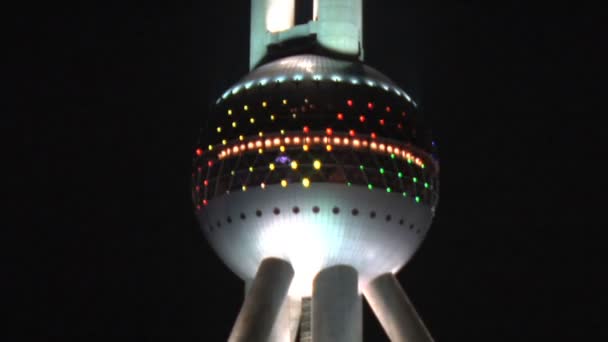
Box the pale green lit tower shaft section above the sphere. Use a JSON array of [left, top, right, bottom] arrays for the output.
[[249, 0, 363, 69]]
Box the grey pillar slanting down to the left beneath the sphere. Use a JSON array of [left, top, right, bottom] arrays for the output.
[[228, 258, 294, 342]]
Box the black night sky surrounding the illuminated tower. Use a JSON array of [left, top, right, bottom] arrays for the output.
[[19, 0, 608, 342]]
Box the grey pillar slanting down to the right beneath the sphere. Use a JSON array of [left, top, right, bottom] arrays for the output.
[[363, 273, 433, 342]]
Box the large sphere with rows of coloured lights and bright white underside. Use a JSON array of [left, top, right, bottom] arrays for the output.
[[193, 55, 439, 296]]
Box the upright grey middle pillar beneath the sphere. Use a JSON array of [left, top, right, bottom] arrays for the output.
[[312, 265, 363, 342]]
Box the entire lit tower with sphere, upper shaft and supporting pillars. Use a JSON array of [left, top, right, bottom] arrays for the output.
[[192, 0, 439, 342]]
